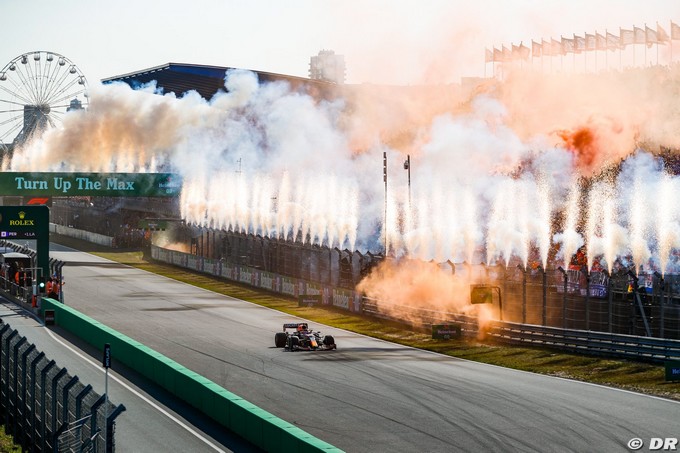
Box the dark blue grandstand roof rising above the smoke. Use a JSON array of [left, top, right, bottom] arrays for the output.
[[102, 63, 335, 100]]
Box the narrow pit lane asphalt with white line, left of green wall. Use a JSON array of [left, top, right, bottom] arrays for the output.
[[0, 301, 257, 452]]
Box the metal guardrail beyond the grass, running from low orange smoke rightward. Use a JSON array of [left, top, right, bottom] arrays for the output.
[[362, 298, 680, 362]]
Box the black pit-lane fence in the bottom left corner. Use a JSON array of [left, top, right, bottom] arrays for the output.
[[0, 324, 125, 453]]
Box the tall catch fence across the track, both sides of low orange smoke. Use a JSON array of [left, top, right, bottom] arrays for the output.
[[183, 230, 680, 339]]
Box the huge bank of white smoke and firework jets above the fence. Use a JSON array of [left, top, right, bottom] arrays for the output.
[[7, 64, 680, 270]]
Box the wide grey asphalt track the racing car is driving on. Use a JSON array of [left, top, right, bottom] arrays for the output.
[[45, 246, 680, 452]]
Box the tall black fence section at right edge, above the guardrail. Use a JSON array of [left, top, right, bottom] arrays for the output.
[[496, 267, 680, 339]]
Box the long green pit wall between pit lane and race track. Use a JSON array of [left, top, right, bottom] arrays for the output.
[[40, 299, 341, 452]]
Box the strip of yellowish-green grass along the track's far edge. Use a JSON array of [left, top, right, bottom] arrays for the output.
[[50, 235, 680, 401]]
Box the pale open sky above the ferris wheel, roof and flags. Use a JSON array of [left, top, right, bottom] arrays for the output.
[[0, 0, 680, 85]]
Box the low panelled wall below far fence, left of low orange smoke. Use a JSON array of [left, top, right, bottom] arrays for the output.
[[151, 245, 361, 312]]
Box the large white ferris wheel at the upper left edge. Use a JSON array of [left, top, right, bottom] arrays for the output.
[[0, 51, 88, 151]]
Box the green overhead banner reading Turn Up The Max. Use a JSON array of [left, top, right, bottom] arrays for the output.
[[0, 172, 182, 197]]
